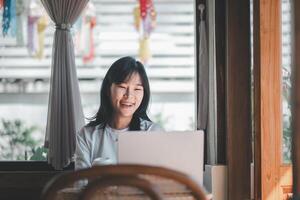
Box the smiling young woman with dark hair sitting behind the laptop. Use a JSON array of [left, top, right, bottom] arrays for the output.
[[75, 57, 160, 169]]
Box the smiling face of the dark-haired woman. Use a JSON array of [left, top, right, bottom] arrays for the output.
[[110, 73, 144, 119]]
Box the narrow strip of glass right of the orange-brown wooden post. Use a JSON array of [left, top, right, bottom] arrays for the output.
[[281, 0, 292, 163]]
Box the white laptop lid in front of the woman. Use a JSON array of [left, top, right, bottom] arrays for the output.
[[117, 131, 204, 185]]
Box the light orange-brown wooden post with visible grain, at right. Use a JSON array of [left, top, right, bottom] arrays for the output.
[[253, 0, 282, 200]]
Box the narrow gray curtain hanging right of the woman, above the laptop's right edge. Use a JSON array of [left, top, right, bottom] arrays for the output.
[[197, 1, 217, 165]]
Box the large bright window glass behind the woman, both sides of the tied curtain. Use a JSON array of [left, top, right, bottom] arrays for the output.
[[0, 0, 195, 160]]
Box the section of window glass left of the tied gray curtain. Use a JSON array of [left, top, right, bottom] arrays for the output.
[[0, 1, 52, 160]]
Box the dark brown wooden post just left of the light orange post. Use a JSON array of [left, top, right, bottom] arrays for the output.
[[226, 0, 251, 200]]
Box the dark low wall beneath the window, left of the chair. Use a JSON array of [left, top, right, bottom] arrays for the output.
[[0, 161, 74, 200]]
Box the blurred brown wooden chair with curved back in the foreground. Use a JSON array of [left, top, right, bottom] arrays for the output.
[[42, 164, 207, 200]]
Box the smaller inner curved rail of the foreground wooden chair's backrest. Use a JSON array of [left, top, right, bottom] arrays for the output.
[[79, 175, 163, 200]]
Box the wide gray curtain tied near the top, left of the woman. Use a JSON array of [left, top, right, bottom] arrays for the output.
[[41, 0, 88, 169]]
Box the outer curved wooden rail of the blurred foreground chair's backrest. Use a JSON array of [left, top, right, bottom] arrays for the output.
[[42, 164, 207, 200]]
